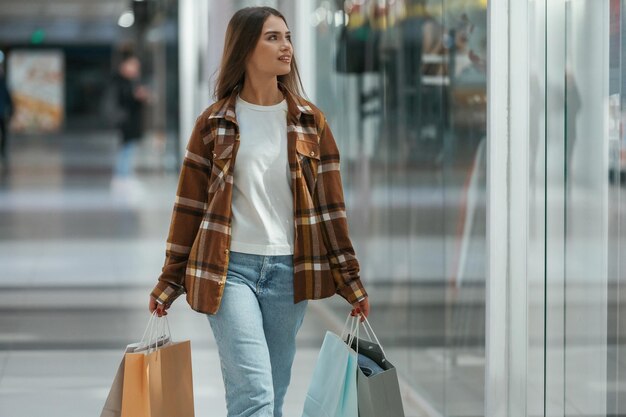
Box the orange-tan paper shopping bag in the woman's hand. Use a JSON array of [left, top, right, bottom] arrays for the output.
[[121, 340, 194, 417]]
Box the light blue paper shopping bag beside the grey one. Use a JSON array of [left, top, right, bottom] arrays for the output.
[[302, 314, 358, 417]]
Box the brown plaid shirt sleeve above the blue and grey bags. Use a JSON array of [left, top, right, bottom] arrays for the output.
[[314, 118, 367, 304]]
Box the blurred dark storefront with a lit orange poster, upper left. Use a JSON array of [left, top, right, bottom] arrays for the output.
[[0, 0, 179, 169]]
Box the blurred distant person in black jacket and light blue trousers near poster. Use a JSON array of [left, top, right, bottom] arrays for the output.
[[111, 53, 150, 192]]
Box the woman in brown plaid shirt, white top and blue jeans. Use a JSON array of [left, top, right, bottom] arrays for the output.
[[149, 7, 369, 417]]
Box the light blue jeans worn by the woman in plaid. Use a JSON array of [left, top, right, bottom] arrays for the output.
[[207, 252, 308, 417]]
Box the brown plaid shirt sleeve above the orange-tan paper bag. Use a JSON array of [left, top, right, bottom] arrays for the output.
[[150, 116, 212, 305]]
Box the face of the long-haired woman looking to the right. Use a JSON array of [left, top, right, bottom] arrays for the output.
[[246, 15, 293, 76]]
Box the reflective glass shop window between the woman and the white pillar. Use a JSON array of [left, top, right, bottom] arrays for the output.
[[311, 0, 487, 416]]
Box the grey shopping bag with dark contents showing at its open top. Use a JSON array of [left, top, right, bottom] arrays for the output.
[[349, 318, 404, 417]]
